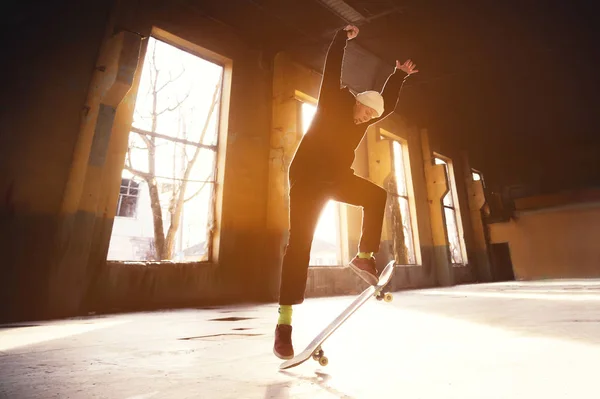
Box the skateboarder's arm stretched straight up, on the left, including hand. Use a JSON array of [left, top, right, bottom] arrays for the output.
[[319, 25, 358, 102]]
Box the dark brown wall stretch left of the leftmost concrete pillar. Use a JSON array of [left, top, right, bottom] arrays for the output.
[[0, 1, 111, 319]]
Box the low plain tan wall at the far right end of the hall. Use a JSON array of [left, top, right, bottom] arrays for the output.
[[489, 190, 600, 280]]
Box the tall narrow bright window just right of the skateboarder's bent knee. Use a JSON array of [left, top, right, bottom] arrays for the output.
[[392, 140, 417, 265]]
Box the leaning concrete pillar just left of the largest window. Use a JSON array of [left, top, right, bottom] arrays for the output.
[[47, 28, 141, 315]]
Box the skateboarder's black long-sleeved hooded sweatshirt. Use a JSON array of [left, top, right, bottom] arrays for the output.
[[290, 29, 409, 180]]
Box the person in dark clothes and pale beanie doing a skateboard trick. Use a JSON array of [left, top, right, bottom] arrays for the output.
[[273, 25, 418, 359]]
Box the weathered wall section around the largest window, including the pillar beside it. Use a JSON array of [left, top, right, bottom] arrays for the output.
[[0, 1, 272, 319]]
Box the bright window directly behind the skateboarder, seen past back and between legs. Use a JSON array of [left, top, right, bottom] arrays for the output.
[[301, 102, 342, 266]]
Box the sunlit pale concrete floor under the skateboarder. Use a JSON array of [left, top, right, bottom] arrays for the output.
[[0, 281, 600, 399]]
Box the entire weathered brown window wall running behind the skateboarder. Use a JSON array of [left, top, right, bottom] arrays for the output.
[[0, 0, 488, 320]]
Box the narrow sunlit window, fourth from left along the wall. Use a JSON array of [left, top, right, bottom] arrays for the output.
[[435, 155, 467, 264]]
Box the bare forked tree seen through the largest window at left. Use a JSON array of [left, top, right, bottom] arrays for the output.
[[125, 39, 222, 260]]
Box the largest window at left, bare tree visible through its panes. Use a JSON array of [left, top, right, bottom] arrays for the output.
[[108, 37, 225, 261]]
